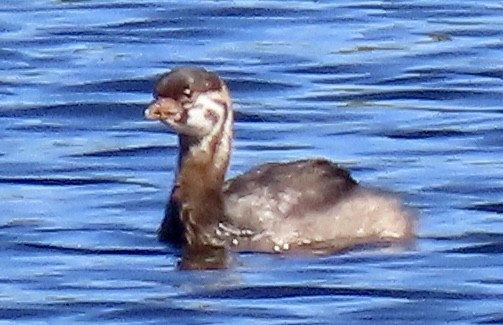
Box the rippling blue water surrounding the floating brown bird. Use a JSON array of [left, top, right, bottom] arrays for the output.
[[0, 0, 503, 324]]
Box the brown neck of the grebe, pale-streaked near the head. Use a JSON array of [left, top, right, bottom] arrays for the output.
[[176, 104, 232, 247]]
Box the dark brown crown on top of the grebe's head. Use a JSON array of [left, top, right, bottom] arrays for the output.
[[154, 67, 223, 100]]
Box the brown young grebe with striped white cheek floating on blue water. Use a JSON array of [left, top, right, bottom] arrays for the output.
[[145, 67, 413, 264]]
